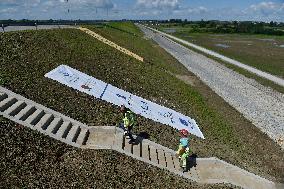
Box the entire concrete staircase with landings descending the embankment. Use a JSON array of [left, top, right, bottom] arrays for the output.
[[0, 87, 284, 189]]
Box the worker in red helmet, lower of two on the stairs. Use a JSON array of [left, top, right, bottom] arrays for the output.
[[176, 129, 190, 172]]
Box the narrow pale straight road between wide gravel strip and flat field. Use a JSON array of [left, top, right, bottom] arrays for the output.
[[144, 25, 284, 87]]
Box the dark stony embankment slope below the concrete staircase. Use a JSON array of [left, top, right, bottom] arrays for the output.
[[0, 117, 239, 189]]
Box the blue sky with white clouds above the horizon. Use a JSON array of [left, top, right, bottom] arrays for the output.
[[0, 0, 284, 22]]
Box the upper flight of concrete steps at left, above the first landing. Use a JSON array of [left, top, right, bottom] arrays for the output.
[[0, 87, 90, 147]]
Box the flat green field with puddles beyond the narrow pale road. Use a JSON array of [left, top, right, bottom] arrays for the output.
[[160, 25, 284, 78]]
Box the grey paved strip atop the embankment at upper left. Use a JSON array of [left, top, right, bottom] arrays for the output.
[[0, 25, 74, 32]]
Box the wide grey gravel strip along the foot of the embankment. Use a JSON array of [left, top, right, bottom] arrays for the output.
[[142, 25, 284, 149]]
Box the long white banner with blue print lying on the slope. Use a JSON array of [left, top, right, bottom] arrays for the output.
[[45, 65, 204, 139]]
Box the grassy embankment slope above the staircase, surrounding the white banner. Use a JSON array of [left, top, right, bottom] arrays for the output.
[[0, 23, 284, 181]]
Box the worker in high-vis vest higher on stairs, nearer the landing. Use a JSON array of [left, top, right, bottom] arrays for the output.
[[120, 105, 136, 143]]
